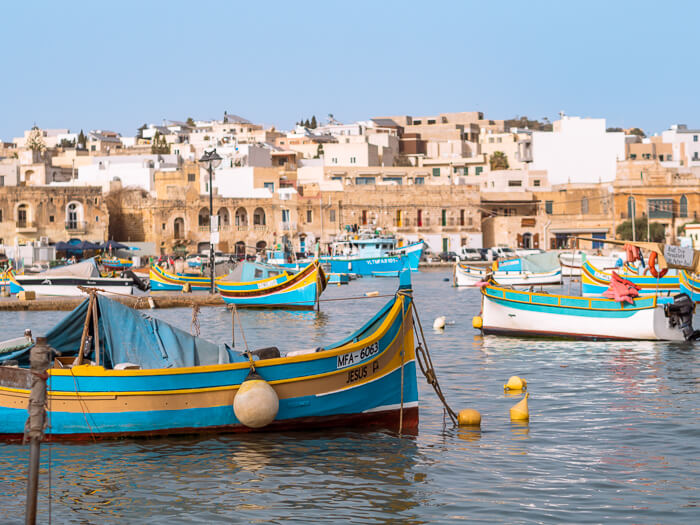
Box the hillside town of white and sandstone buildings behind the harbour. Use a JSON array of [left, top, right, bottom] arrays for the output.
[[0, 111, 700, 262]]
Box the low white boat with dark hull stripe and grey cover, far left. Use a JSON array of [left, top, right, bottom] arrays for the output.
[[6, 258, 136, 296]]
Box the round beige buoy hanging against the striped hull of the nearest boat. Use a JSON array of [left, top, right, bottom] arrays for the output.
[[233, 372, 280, 428]]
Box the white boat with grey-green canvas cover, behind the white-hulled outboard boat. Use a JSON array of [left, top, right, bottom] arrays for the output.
[[452, 252, 561, 286]]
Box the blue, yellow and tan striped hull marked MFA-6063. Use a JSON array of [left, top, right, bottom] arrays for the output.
[[0, 295, 418, 440]]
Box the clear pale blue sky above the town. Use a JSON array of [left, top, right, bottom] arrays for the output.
[[0, 0, 700, 140]]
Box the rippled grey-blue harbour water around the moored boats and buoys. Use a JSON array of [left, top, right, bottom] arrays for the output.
[[0, 270, 700, 524]]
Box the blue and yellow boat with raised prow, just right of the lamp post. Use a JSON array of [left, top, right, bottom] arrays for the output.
[[216, 261, 328, 309]]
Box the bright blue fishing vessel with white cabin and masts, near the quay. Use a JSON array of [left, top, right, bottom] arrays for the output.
[[321, 233, 425, 276]]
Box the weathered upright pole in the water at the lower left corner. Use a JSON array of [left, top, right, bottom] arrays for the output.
[[24, 337, 51, 525]]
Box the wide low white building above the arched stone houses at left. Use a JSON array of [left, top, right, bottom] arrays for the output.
[[76, 155, 178, 193]]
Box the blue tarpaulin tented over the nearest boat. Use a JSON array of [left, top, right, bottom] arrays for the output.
[[2, 295, 246, 369]]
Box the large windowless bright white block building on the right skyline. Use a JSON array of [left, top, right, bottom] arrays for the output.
[[530, 116, 625, 184]]
